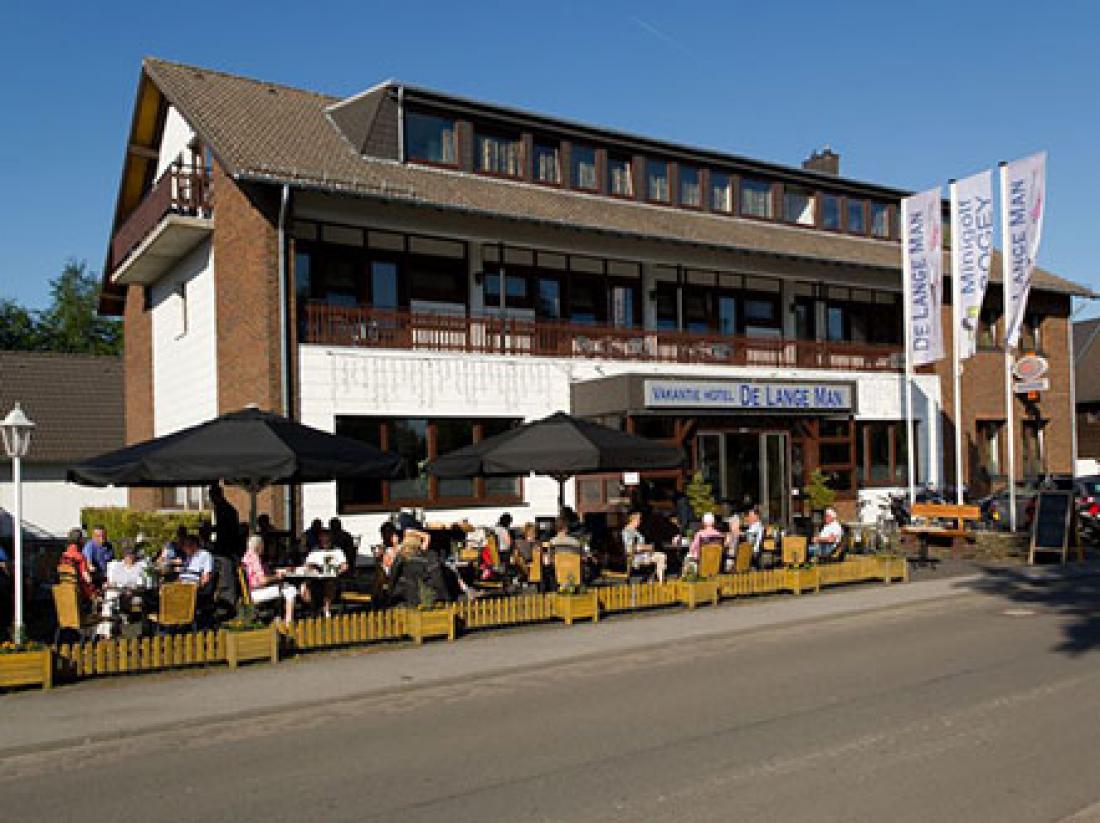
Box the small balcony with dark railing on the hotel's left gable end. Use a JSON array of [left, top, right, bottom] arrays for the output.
[[110, 164, 213, 285]]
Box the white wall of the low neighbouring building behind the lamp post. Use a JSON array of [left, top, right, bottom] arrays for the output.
[[0, 461, 127, 537]]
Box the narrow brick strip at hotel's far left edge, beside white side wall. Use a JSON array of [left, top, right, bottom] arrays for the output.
[[122, 286, 161, 509]]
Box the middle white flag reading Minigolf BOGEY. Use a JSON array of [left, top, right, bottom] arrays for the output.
[[952, 172, 993, 360]]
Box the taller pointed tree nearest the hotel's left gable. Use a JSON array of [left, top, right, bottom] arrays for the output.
[[40, 260, 122, 354]]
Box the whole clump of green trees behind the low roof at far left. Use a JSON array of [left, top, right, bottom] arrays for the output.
[[0, 260, 122, 354]]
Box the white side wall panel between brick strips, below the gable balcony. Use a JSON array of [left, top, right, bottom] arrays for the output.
[[150, 240, 218, 437]]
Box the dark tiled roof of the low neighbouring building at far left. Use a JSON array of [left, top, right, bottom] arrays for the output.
[[0, 351, 125, 463]]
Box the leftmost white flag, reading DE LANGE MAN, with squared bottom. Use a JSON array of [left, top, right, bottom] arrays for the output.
[[901, 188, 944, 366]]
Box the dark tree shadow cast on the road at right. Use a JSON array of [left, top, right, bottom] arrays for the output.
[[967, 563, 1100, 655]]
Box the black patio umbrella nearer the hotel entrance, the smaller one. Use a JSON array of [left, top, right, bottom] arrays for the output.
[[427, 412, 684, 508]]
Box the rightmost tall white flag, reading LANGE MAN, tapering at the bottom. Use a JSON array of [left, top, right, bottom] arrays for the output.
[[1001, 152, 1046, 349]]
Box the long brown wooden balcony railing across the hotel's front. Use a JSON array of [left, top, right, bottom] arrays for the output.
[[301, 303, 904, 372]]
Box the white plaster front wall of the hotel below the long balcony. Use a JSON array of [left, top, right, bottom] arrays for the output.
[[299, 345, 941, 545]]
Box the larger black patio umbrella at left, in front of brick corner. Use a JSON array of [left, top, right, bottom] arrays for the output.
[[68, 408, 402, 525]]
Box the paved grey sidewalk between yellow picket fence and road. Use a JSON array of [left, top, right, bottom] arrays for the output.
[[0, 567, 1097, 759]]
